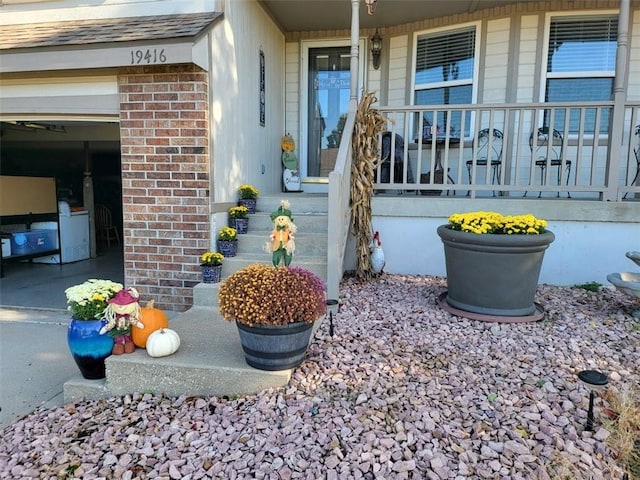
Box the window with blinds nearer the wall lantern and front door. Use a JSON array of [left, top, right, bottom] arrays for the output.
[[414, 25, 477, 133]]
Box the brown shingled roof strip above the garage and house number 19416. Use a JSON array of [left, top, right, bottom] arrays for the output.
[[0, 12, 222, 50]]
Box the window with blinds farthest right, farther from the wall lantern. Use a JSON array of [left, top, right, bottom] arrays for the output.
[[545, 15, 618, 133]]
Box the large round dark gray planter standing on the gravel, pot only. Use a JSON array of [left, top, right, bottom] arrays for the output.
[[438, 225, 555, 317]]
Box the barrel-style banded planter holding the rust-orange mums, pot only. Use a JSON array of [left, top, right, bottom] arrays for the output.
[[236, 322, 313, 371]]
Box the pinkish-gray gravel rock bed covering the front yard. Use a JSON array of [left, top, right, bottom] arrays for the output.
[[0, 275, 640, 480]]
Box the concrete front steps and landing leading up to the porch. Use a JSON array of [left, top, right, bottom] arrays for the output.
[[63, 194, 328, 403]]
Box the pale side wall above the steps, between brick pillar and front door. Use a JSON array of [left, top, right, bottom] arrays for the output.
[[210, 1, 285, 199]]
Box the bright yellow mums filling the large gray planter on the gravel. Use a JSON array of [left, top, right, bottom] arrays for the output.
[[449, 212, 547, 235]]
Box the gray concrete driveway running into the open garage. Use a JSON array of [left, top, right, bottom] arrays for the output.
[[0, 245, 124, 429]]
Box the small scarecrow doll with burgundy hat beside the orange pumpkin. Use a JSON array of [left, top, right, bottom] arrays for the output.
[[100, 288, 144, 355]]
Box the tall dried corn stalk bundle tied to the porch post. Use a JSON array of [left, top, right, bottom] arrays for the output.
[[351, 93, 385, 280]]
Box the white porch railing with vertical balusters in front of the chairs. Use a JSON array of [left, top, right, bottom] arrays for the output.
[[375, 102, 640, 201]]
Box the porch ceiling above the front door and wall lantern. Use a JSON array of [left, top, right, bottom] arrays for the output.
[[260, 0, 518, 32]]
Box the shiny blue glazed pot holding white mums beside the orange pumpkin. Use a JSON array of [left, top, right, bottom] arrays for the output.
[[67, 318, 113, 380]]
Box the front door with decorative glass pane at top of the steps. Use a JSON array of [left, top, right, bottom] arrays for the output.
[[306, 46, 351, 180]]
